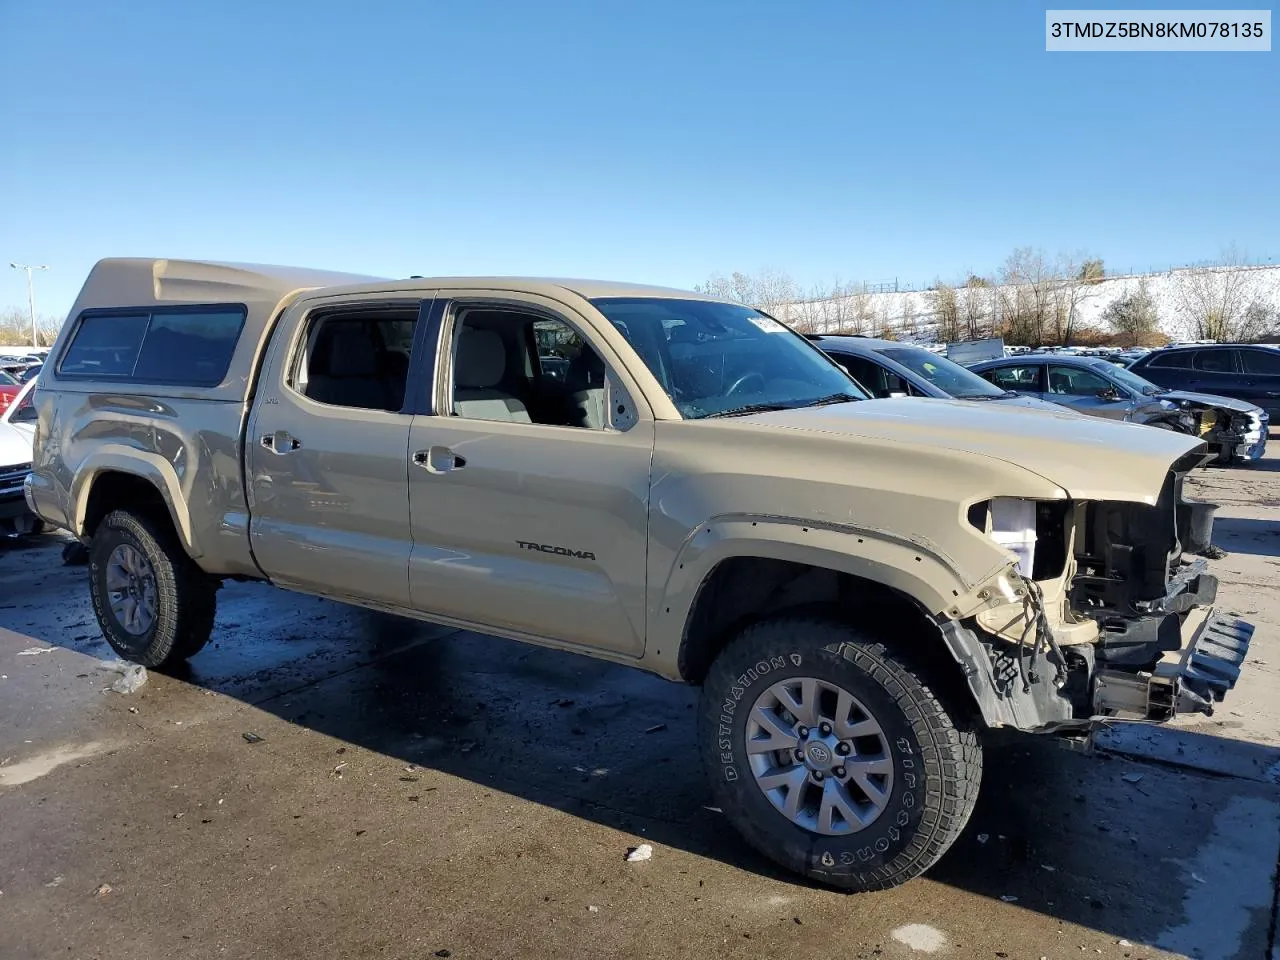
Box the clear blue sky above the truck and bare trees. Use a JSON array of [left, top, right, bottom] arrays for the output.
[[0, 0, 1280, 320]]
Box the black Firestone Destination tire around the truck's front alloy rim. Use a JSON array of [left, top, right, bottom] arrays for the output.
[[699, 616, 982, 892]]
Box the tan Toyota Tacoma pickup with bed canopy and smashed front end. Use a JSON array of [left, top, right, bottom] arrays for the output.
[[26, 260, 1252, 890]]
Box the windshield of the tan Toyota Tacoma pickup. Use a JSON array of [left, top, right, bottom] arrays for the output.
[[591, 297, 868, 420]]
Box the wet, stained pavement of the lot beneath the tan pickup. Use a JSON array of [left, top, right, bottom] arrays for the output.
[[0, 456, 1280, 960]]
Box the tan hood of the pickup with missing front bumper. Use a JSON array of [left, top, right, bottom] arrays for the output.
[[744, 397, 1204, 503]]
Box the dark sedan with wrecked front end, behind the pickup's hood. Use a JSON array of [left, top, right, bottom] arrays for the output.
[[972, 353, 1270, 463]]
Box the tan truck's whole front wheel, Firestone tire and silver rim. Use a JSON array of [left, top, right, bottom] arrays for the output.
[[700, 617, 982, 891]]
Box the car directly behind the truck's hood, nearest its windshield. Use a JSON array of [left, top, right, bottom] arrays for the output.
[[809, 334, 1061, 412]]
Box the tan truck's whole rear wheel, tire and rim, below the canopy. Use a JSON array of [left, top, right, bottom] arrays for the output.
[[90, 511, 216, 667]]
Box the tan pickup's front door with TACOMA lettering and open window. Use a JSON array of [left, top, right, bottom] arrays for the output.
[[408, 293, 654, 655]]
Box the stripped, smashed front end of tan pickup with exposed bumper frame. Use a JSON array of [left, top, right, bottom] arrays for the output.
[[940, 448, 1253, 732]]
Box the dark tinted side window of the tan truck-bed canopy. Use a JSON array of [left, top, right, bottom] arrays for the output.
[[58, 305, 244, 387]]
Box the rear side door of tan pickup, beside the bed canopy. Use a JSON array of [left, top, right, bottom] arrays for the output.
[[246, 294, 429, 607]]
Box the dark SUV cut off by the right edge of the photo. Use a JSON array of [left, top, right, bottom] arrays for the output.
[[1129, 343, 1280, 422]]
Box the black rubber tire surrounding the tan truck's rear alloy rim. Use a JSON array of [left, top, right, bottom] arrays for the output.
[[88, 509, 218, 667]]
